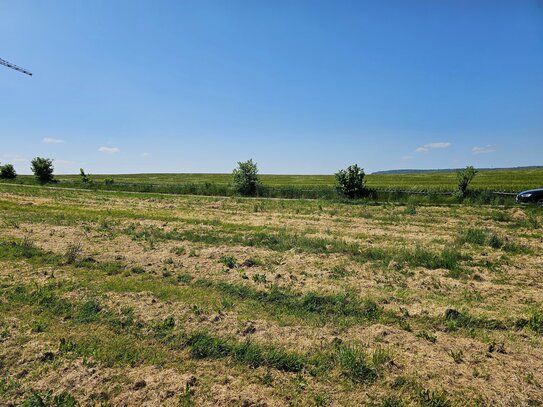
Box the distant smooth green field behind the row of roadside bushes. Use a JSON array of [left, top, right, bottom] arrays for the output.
[[9, 169, 543, 192]]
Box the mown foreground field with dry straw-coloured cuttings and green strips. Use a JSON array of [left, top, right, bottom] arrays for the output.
[[0, 185, 543, 407]]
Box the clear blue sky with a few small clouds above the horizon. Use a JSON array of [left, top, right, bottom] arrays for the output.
[[0, 0, 543, 174]]
